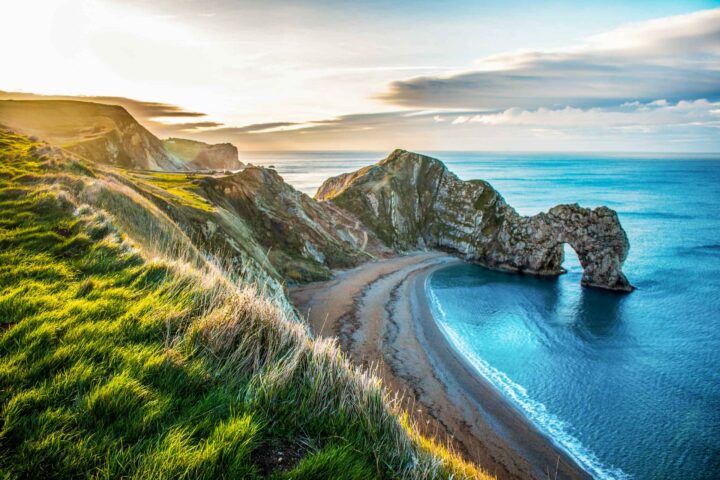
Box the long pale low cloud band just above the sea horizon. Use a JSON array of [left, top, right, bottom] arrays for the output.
[[187, 99, 720, 151]]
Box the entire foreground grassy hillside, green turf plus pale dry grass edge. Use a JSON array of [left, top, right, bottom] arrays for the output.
[[0, 130, 490, 479]]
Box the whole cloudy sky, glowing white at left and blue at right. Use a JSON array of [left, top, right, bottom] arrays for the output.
[[0, 0, 720, 152]]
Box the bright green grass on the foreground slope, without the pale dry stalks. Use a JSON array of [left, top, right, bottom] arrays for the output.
[[0, 135, 264, 478]]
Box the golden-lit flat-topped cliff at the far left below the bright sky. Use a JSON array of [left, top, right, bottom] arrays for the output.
[[0, 100, 187, 171]]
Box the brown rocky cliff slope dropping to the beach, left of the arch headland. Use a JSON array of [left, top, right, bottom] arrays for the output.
[[196, 167, 391, 281]]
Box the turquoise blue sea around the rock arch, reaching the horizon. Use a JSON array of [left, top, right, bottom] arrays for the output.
[[242, 152, 720, 480]]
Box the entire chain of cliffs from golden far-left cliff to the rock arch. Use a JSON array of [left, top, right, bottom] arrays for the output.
[[0, 100, 632, 291]]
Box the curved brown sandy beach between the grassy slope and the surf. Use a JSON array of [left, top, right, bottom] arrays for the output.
[[290, 252, 589, 479]]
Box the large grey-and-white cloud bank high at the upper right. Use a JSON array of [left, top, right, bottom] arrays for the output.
[[379, 9, 720, 109]]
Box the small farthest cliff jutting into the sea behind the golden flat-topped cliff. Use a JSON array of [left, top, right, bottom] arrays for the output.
[[163, 138, 243, 170]]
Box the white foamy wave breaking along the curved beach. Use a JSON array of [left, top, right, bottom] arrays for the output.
[[425, 278, 632, 480]]
